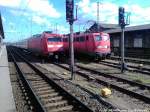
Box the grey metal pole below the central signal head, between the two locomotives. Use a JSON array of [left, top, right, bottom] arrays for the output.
[[69, 22, 75, 80]]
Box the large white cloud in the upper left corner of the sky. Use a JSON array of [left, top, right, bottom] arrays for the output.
[[0, 0, 61, 18]]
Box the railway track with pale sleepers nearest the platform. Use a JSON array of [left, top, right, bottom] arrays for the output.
[[9, 49, 93, 112]]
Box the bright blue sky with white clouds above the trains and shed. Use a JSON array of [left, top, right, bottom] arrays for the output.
[[0, 0, 150, 42]]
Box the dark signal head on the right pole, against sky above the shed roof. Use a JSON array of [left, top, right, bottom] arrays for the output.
[[119, 7, 125, 27]]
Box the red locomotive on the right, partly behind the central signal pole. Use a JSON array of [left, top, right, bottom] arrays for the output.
[[63, 32, 110, 59]]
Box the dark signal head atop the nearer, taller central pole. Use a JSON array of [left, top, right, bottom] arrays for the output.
[[66, 0, 74, 22]]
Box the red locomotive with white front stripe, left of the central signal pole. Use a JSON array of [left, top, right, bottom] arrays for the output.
[[27, 31, 63, 56]]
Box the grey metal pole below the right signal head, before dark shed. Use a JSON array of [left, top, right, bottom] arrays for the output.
[[121, 28, 125, 73]]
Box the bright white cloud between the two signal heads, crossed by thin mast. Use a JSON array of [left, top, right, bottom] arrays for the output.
[[78, 0, 118, 22]]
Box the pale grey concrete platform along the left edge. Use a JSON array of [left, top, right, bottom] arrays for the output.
[[0, 45, 16, 112]]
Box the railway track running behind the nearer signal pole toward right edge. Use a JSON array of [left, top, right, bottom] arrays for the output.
[[53, 64, 150, 104]]
